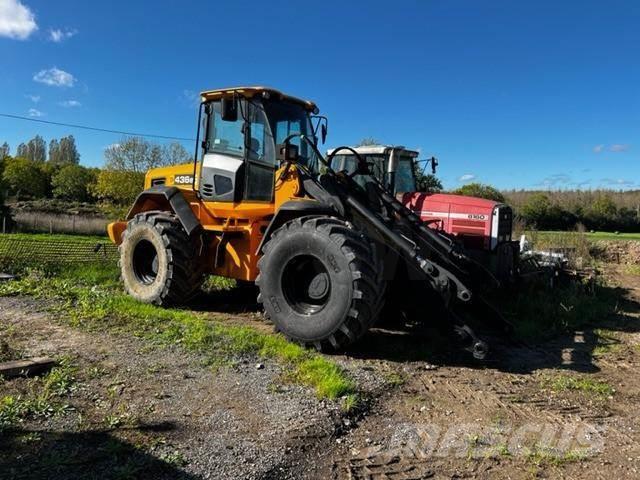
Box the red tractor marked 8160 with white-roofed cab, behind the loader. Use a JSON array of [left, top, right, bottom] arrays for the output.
[[329, 145, 519, 283]]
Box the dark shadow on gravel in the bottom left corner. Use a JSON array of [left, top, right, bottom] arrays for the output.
[[0, 424, 196, 480]]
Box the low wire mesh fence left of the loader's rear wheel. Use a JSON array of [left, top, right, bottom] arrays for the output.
[[0, 234, 118, 266]]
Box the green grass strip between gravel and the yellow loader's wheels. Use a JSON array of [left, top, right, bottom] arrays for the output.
[[0, 265, 357, 399]]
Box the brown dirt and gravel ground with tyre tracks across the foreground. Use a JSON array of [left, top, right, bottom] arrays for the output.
[[0, 270, 640, 479]]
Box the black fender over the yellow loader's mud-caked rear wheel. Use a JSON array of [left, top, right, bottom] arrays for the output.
[[127, 185, 202, 235]]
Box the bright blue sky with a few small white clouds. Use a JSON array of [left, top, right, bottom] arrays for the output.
[[0, 0, 640, 189]]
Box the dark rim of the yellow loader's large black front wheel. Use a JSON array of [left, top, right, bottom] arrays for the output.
[[282, 255, 331, 315]]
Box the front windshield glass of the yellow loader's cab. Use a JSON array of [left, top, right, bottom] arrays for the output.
[[262, 100, 319, 173]]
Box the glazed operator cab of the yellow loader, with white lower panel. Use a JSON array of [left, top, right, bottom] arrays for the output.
[[198, 94, 317, 203]]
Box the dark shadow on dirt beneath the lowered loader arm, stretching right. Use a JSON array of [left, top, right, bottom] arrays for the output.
[[347, 287, 640, 373]]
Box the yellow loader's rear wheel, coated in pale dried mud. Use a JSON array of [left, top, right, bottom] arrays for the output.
[[120, 211, 204, 306]]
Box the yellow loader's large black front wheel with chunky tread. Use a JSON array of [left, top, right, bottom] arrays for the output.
[[256, 217, 382, 351]]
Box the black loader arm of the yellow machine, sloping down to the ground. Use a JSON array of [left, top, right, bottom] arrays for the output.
[[287, 135, 507, 359]]
